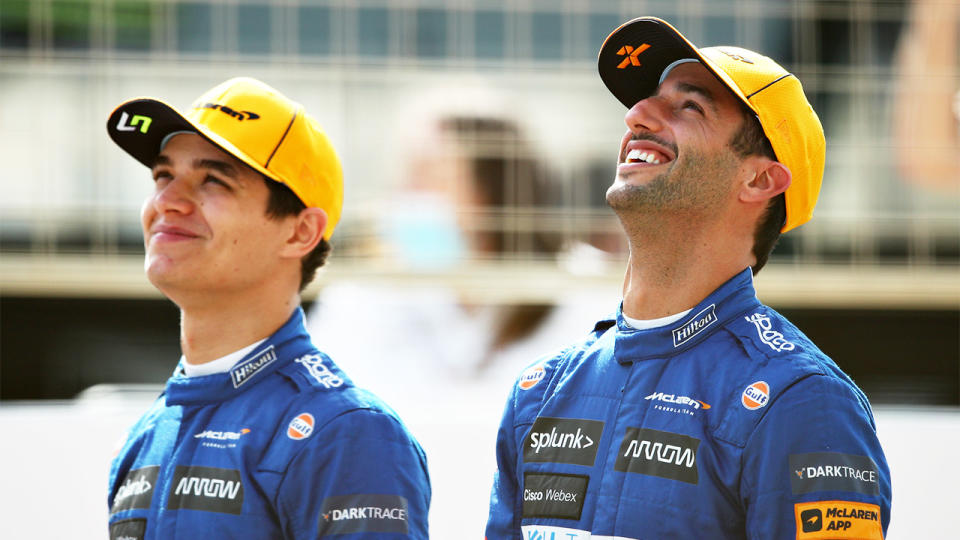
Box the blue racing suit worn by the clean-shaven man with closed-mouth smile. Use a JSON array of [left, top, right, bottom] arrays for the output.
[[108, 309, 430, 540]]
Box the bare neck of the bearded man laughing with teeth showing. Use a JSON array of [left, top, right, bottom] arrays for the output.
[[623, 211, 753, 319]]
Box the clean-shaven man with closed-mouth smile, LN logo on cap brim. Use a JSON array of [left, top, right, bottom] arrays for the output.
[[107, 78, 430, 539]]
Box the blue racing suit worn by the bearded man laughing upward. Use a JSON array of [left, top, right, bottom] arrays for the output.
[[486, 269, 890, 540]]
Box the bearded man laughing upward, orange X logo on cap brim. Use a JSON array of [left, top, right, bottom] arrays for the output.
[[486, 17, 890, 540]]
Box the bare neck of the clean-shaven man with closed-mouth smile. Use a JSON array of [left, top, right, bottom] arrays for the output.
[[180, 286, 300, 364]]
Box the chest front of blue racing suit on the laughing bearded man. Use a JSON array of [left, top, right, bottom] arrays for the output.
[[515, 324, 773, 538]]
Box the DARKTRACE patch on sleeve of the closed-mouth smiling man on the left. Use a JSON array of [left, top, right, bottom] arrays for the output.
[[319, 493, 410, 537]]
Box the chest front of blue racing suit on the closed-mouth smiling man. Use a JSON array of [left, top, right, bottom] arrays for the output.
[[110, 360, 333, 538]]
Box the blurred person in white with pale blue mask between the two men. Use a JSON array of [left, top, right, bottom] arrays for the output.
[[307, 95, 615, 538]]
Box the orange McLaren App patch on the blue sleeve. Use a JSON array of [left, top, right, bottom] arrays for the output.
[[793, 501, 883, 540]]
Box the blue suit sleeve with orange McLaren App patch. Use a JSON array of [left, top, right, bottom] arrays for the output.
[[740, 375, 891, 539]]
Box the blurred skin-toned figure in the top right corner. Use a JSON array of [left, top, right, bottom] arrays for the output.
[[892, 0, 960, 193]]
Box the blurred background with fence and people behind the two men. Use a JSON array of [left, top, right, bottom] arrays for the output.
[[0, 0, 960, 539]]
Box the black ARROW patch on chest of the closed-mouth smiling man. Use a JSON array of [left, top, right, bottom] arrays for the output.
[[167, 465, 243, 515]]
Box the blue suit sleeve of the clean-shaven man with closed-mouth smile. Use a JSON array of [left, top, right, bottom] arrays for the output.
[[276, 409, 430, 540]]
